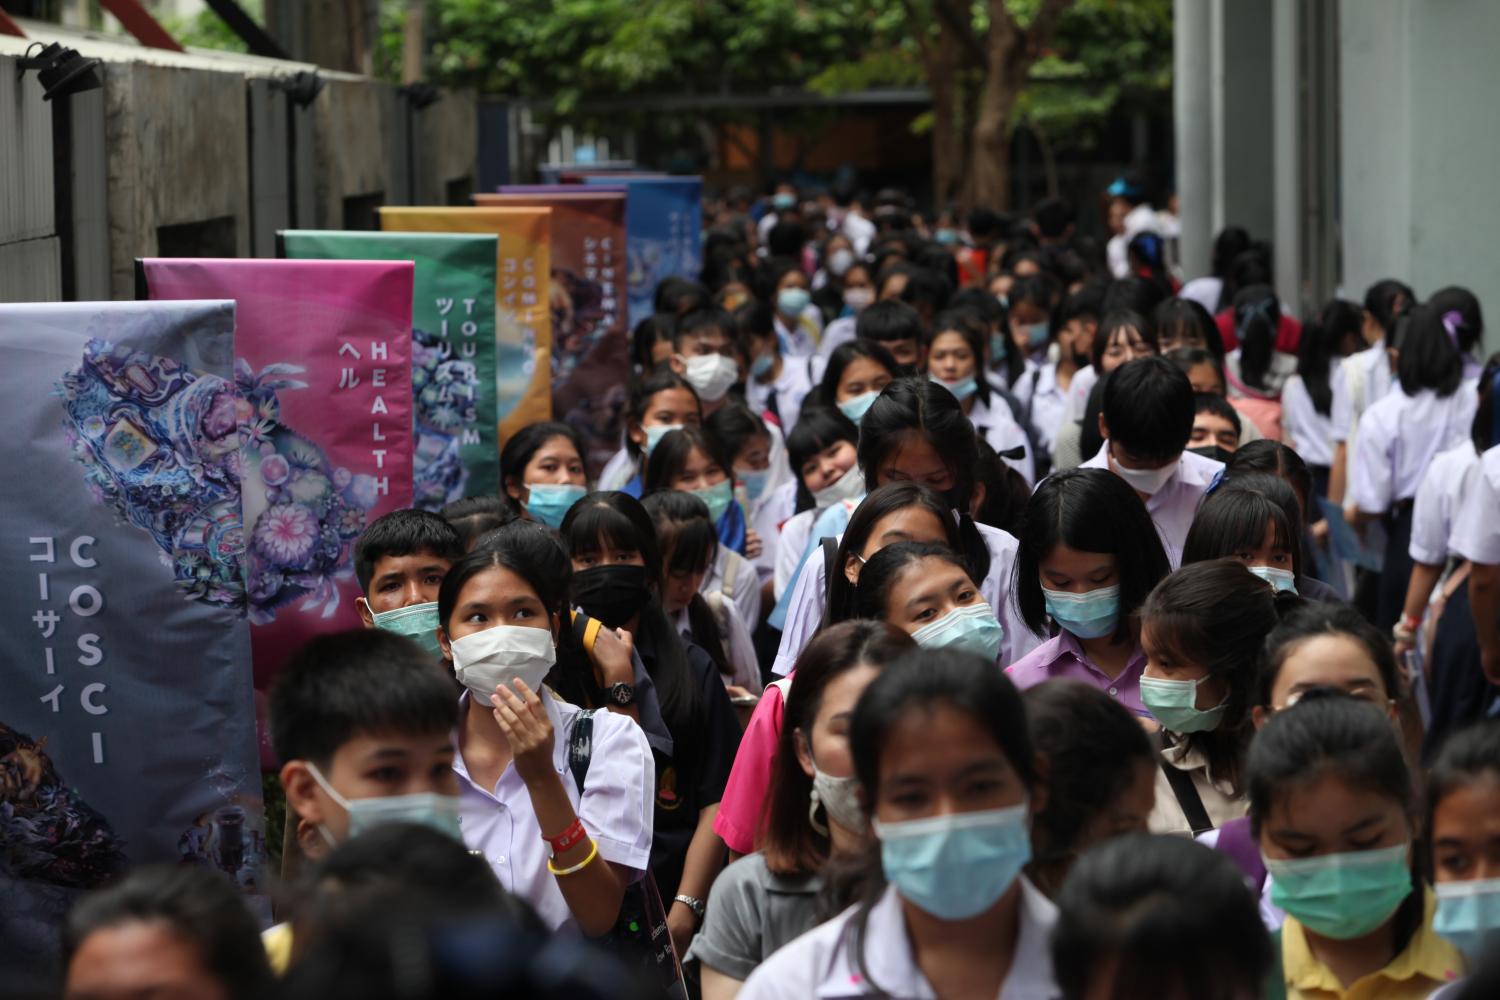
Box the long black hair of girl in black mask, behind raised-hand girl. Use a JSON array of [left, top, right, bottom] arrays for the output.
[[560, 490, 699, 733]]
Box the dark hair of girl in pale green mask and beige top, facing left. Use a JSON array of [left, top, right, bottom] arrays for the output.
[[1140, 559, 1298, 793]]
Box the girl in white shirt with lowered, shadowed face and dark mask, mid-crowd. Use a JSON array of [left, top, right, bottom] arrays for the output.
[[773, 378, 1038, 675]]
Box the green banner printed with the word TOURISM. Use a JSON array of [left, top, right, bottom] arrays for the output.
[[278, 229, 500, 511]]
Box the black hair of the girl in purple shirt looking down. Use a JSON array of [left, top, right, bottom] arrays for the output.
[[1011, 469, 1172, 642]]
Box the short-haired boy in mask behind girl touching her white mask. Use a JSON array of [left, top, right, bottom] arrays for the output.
[[354, 510, 464, 658]]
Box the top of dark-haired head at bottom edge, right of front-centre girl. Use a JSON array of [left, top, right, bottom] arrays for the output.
[[1052, 834, 1275, 1000]]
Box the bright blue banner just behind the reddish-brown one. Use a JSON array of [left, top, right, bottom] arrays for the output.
[[582, 174, 704, 325]]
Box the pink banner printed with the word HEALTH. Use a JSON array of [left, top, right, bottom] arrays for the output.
[[137, 259, 413, 688]]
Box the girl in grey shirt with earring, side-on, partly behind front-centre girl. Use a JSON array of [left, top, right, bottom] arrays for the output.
[[689, 622, 912, 1000]]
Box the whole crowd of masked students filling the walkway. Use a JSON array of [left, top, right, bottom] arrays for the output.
[[46, 183, 1500, 1000]]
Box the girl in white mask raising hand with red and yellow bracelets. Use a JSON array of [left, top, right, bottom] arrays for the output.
[[438, 523, 654, 937]]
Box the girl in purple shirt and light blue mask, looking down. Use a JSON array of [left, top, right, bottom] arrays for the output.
[[1007, 469, 1172, 715]]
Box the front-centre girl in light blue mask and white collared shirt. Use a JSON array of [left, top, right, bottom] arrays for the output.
[[740, 651, 1058, 1000]]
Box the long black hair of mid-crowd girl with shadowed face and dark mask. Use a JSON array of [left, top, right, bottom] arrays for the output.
[[860, 378, 990, 583]]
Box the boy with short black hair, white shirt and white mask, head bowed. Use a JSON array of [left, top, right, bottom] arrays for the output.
[[1083, 357, 1224, 567]]
